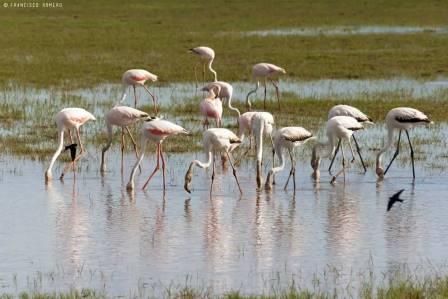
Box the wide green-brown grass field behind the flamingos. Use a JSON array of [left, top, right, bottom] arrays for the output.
[[0, 0, 448, 88]]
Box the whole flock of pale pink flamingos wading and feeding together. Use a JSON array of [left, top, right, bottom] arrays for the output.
[[45, 46, 432, 194]]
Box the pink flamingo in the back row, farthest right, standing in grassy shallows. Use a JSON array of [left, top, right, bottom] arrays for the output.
[[246, 63, 286, 110]]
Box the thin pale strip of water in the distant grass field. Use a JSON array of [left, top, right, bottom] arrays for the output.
[[242, 26, 448, 36]]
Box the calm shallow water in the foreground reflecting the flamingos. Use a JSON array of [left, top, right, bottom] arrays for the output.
[[0, 79, 448, 296]]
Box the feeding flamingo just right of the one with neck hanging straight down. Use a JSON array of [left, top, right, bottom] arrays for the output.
[[265, 127, 315, 191]]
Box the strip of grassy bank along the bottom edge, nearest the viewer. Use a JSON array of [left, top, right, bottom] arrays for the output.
[[0, 276, 448, 299]]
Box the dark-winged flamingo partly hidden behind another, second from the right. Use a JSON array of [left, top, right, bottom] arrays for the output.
[[328, 105, 373, 172]]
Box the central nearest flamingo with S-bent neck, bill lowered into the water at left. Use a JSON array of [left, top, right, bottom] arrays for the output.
[[184, 128, 243, 195]]
